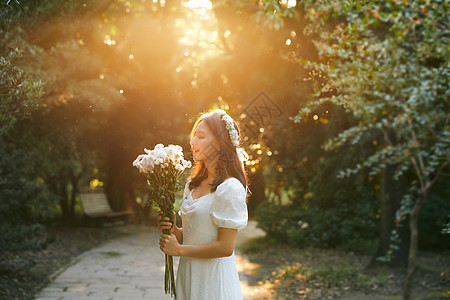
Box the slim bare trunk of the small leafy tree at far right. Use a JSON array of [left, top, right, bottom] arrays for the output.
[[403, 187, 428, 300]]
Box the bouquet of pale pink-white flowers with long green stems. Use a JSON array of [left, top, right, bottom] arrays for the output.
[[133, 144, 192, 299]]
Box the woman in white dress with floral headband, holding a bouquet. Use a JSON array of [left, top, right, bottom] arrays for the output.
[[158, 109, 248, 300]]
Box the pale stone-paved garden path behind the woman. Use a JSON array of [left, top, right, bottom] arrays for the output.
[[36, 221, 264, 300]]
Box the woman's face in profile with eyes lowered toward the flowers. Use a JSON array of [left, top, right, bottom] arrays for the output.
[[191, 121, 219, 162]]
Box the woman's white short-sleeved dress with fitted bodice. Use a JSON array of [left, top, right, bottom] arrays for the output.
[[176, 177, 248, 300]]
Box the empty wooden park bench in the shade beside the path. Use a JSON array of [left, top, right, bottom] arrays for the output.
[[80, 193, 129, 224]]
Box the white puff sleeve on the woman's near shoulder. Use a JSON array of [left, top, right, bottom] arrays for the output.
[[210, 177, 248, 230]]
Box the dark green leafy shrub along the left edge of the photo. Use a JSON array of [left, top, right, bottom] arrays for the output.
[[0, 48, 55, 230]]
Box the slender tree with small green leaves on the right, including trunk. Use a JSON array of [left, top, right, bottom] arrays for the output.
[[293, 1, 450, 299]]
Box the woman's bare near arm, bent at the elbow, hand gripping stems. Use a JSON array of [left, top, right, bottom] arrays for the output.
[[159, 227, 237, 258]]
